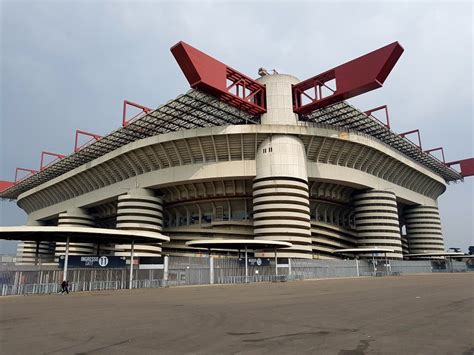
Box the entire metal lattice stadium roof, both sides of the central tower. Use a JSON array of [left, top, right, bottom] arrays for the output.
[[0, 90, 463, 199]]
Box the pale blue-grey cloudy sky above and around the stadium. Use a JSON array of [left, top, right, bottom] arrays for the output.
[[0, 0, 474, 254]]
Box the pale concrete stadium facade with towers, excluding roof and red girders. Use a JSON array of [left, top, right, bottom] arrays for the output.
[[8, 74, 456, 263]]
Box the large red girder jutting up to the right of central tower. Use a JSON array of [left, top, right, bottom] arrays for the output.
[[293, 42, 403, 114]]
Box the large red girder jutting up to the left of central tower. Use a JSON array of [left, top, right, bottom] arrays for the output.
[[171, 42, 266, 114]]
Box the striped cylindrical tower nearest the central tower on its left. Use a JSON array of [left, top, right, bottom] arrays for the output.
[[115, 189, 163, 256]]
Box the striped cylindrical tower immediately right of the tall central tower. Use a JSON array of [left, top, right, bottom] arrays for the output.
[[354, 190, 403, 259]]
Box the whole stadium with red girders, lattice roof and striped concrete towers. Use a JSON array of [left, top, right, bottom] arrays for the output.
[[0, 42, 474, 264]]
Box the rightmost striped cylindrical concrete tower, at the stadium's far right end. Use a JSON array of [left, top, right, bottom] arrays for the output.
[[404, 206, 444, 254]]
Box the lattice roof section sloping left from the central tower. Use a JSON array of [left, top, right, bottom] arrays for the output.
[[0, 90, 259, 199]]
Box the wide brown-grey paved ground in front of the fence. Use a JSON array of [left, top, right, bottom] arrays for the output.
[[0, 273, 474, 355]]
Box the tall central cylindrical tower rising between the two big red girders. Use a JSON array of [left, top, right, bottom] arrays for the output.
[[253, 74, 312, 258]]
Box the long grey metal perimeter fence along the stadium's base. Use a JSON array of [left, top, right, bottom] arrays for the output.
[[0, 256, 474, 296]]
